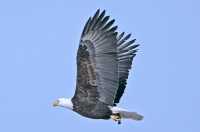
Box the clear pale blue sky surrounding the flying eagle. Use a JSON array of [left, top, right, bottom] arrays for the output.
[[0, 0, 200, 132]]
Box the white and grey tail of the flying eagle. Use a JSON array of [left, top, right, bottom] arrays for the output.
[[111, 107, 143, 121]]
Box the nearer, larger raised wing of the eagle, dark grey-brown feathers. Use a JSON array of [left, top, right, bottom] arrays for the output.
[[74, 10, 119, 106]]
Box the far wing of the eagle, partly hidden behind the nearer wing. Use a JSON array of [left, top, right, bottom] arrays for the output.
[[114, 32, 139, 104]]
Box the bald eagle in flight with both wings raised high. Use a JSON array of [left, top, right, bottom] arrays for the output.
[[53, 9, 143, 124]]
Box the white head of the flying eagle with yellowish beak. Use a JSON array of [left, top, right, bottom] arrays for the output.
[[53, 98, 73, 110]]
